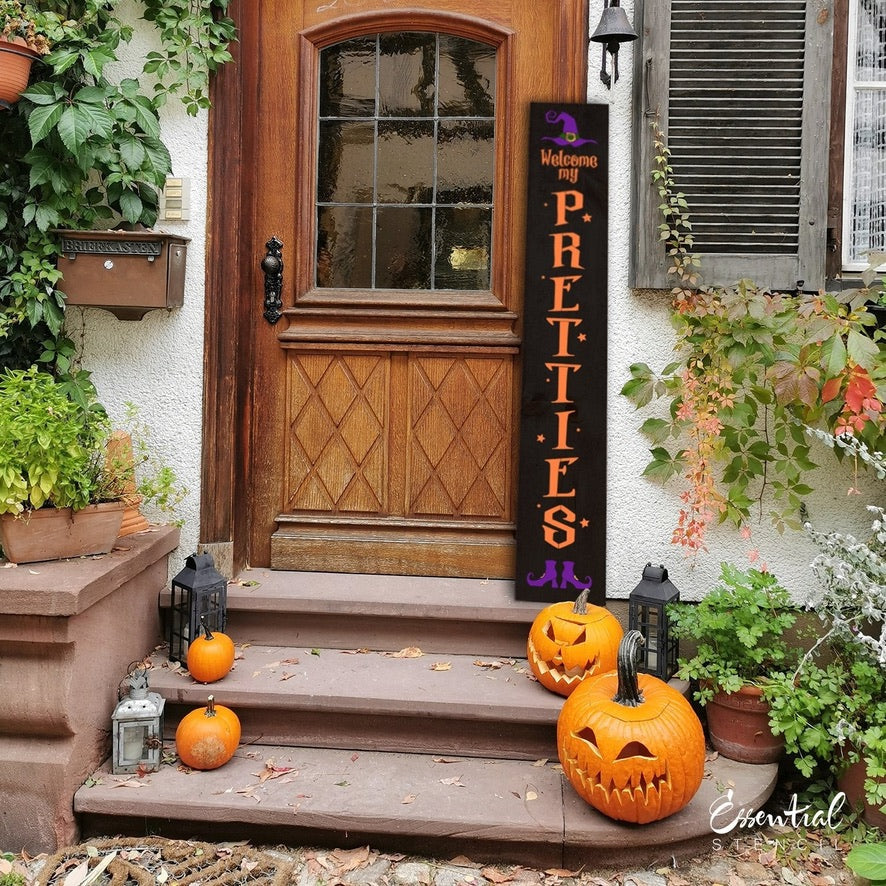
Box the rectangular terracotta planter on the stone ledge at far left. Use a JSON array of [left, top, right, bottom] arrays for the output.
[[0, 501, 125, 563]]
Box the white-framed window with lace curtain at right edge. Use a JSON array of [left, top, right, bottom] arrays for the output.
[[842, 0, 886, 271]]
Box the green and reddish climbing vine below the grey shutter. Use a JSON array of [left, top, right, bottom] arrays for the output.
[[622, 122, 886, 551]]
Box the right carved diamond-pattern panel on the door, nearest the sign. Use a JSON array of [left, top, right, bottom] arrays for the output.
[[407, 355, 512, 520]]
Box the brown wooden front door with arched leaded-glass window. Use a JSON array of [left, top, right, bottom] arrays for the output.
[[243, 0, 587, 577]]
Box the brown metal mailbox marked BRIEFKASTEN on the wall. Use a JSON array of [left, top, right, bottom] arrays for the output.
[[56, 231, 189, 320]]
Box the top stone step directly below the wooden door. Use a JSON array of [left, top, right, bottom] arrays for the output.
[[160, 569, 556, 656]]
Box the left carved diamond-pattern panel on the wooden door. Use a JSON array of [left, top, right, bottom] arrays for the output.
[[286, 351, 390, 514]]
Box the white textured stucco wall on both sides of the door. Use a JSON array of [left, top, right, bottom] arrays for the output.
[[68, 0, 886, 599]]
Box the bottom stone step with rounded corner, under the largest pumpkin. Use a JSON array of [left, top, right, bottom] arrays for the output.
[[74, 745, 778, 868]]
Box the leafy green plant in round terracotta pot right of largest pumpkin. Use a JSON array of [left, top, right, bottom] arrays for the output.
[[668, 563, 798, 763]]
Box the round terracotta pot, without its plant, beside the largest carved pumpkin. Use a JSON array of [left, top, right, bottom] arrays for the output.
[[705, 686, 784, 763]]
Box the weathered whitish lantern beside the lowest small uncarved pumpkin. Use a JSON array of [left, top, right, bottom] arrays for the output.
[[111, 661, 166, 775]]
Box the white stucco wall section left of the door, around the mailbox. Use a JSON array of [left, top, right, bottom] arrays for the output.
[[66, 0, 208, 560]]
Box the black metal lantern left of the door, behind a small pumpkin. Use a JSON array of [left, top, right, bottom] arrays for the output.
[[168, 554, 228, 664]]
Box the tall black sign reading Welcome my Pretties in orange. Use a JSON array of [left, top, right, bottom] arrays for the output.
[[515, 102, 609, 604]]
